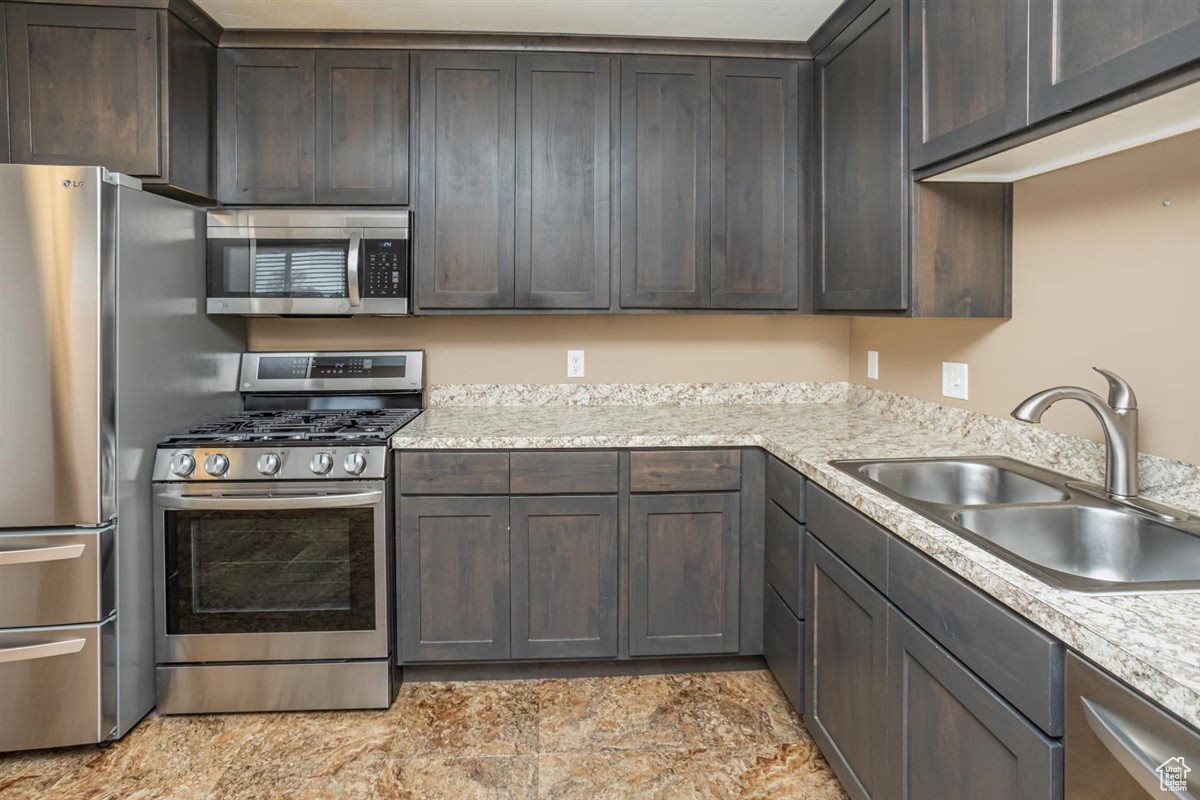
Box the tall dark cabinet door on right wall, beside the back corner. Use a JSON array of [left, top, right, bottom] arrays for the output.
[[816, 0, 908, 311]]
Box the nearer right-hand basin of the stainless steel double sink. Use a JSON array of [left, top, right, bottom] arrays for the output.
[[952, 504, 1200, 591]]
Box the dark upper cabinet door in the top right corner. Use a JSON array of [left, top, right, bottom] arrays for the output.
[[1027, 0, 1200, 122]]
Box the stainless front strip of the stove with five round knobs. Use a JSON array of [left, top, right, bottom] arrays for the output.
[[154, 445, 388, 482]]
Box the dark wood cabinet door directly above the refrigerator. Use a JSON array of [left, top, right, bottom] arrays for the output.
[[6, 4, 161, 176]]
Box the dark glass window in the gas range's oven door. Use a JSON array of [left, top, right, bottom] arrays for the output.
[[166, 509, 372, 634]]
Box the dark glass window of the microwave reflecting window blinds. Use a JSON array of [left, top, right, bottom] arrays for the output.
[[209, 239, 349, 297]]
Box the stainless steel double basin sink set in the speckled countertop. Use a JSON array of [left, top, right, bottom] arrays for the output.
[[832, 457, 1200, 594]]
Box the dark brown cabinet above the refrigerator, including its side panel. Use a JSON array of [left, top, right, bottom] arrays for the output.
[[0, 2, 216, 197]]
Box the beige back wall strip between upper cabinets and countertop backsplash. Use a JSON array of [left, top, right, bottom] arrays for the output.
[[250, 314, 850, 384]]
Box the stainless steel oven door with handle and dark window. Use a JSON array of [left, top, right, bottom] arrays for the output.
[[155, 481, 389, 663]]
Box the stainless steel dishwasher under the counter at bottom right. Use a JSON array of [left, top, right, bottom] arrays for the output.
[[1066, 654, 1200, 800]]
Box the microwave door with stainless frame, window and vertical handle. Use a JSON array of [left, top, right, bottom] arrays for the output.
[[208, 227, 362, 315]]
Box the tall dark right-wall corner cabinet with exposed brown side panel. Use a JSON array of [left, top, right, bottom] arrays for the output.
[[814, 0, 1012, 317]]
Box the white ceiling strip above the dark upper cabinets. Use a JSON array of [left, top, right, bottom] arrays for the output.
[[197, 0, 840, 41]]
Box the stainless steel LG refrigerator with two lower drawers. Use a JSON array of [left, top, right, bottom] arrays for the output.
[[0, 164, 245, 751]]
